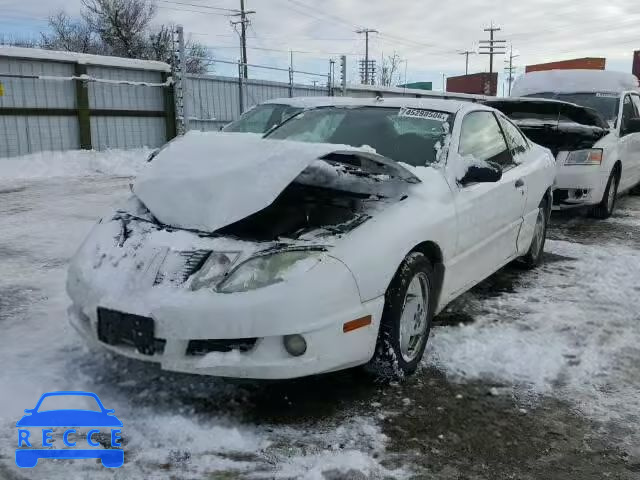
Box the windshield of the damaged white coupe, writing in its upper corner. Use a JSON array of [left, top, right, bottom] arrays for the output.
[[267, 107, 452, 166]]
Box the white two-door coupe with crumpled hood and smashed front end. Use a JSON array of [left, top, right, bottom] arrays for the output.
[[67, 98, 555, 379]]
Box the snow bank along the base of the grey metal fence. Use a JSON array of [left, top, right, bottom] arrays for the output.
[[0, 148, 152, 181]]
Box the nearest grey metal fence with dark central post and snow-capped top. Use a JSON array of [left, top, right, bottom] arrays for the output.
[[0, 47, 175, 157]]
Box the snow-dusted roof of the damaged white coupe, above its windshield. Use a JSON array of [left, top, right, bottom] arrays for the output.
[[264, 97, 489, 113]]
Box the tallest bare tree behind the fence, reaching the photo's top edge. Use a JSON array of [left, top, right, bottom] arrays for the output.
[[82, 0, 156, 58]]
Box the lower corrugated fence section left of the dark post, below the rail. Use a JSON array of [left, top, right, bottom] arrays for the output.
[[0, 115, 80, 157]]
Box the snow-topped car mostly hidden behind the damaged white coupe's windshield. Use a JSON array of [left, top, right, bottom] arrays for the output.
[[222, 97, 335, 134]]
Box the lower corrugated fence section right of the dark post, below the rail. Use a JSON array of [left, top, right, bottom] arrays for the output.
[[91, 115, 166, 150]]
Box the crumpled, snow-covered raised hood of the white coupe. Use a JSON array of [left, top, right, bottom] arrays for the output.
[[133, 132, 362, 232]]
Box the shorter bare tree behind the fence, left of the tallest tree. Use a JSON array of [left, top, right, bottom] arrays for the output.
[[40, 12, 103, 53]]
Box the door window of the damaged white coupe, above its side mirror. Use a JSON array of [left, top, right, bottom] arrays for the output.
[[458, 112, 513, 168]]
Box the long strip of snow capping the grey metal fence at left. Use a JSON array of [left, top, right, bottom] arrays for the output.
[[0, 45, 171, 72]]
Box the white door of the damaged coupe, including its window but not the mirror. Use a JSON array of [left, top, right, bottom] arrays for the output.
[[442, 110, 527, 296]]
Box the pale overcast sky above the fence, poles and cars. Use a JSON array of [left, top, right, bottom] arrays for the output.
[[0, 0, 640, 89]]
